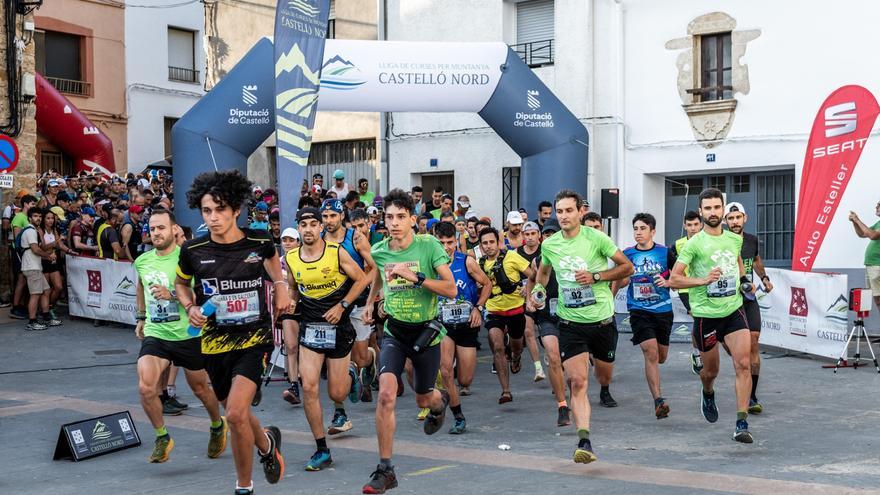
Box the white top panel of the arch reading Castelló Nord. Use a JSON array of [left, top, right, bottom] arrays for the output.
[[318, 39, 508, 112]]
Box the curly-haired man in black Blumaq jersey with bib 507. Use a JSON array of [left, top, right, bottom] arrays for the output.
[[174, 171, 290, 495]]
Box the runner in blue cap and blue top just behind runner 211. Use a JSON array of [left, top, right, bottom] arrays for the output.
[[321, 199, 376, 435]]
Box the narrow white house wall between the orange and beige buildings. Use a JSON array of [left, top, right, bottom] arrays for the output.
[[125, 0, 205, 172]]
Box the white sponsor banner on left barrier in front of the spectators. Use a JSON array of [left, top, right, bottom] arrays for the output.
[[66, 256, 137, 325]]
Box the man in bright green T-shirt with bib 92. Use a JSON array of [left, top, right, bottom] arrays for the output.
[[531, 190, 633, 463]]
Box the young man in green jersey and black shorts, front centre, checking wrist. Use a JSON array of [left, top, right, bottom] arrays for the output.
[[363, 189, 458, 493]]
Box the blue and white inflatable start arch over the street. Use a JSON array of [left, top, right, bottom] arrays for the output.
[[172, 38, 589, 229]]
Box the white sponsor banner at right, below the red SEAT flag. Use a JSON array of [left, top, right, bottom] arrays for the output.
[[758, 268, 849, 358]]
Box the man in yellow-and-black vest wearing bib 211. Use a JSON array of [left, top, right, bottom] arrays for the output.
[[285, 207, 369, 471]]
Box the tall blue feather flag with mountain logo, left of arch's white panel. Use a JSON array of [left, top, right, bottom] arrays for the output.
[[275, 0, 330, 229]]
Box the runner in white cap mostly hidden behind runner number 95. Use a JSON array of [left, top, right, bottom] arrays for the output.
[[724, 202, 773, 414]]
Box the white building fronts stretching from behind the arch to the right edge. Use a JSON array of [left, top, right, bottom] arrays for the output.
[[386, 0, 880, 278]]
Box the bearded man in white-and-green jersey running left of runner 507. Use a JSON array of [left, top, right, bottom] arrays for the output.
[[134, 209, 227, 462]]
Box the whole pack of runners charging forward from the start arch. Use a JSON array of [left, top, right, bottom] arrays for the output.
[[135, 172, 773, 495]]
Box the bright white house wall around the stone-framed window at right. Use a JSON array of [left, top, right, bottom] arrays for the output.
[[616, 0, 880, 269]]
